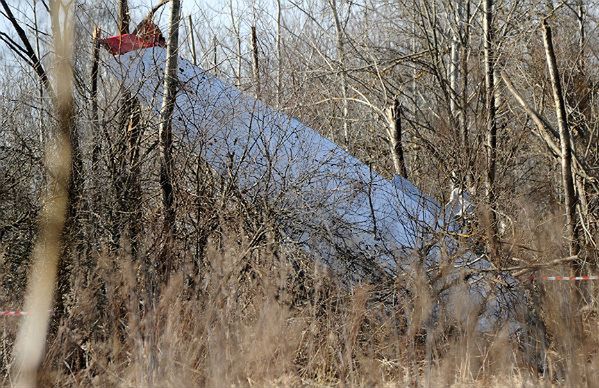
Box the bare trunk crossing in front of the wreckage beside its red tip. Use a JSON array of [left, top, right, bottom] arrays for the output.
[[158, 0, 181, 280]]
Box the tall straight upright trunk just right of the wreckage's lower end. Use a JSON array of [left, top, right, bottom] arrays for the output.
[[483, 0, 499, 263]]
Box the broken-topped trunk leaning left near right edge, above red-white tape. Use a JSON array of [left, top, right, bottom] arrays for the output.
[[543, 20, 580, 260]]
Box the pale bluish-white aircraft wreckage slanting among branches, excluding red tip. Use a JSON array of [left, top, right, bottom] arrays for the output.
[[108, 47, 548, 362]]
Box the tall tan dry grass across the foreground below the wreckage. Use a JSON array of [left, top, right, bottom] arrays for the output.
[[0, 215, 599, 387]]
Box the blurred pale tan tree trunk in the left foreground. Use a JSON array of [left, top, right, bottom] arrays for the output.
[[13, 1, 75, 387]]
